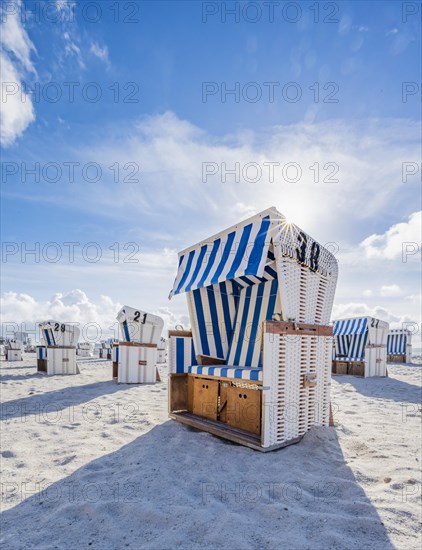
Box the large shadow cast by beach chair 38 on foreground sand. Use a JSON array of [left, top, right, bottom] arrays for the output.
[[1, 421, 393, 550]]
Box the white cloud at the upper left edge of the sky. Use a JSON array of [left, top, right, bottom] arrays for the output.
[[0, 1, 36, 147]]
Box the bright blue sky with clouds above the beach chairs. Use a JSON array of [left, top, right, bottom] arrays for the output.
[[1, 0, 421, 344]]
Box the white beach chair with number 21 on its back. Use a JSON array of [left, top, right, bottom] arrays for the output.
[[113, 306, 164, 384]]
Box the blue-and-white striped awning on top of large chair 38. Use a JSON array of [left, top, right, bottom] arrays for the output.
[[170, 214, 271, 298]]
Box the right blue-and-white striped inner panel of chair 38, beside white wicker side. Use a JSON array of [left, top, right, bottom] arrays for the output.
[[227, 279, 281, 368]]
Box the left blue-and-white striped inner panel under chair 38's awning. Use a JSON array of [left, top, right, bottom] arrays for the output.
[[187, 281, 241, 359]]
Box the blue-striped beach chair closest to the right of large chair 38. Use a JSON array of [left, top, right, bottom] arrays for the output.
[[333, 317, 389, 377]]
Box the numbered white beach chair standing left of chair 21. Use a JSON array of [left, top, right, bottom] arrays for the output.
[[39, 321, 80, 375]]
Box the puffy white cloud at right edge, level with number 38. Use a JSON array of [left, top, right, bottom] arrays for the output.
[[360, 211, 422, 261]]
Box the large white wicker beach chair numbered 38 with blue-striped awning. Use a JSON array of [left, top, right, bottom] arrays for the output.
[[169, 208, 337, 451]]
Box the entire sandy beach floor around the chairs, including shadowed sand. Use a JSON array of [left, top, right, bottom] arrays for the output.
[[0, 354, 421, 550]]
